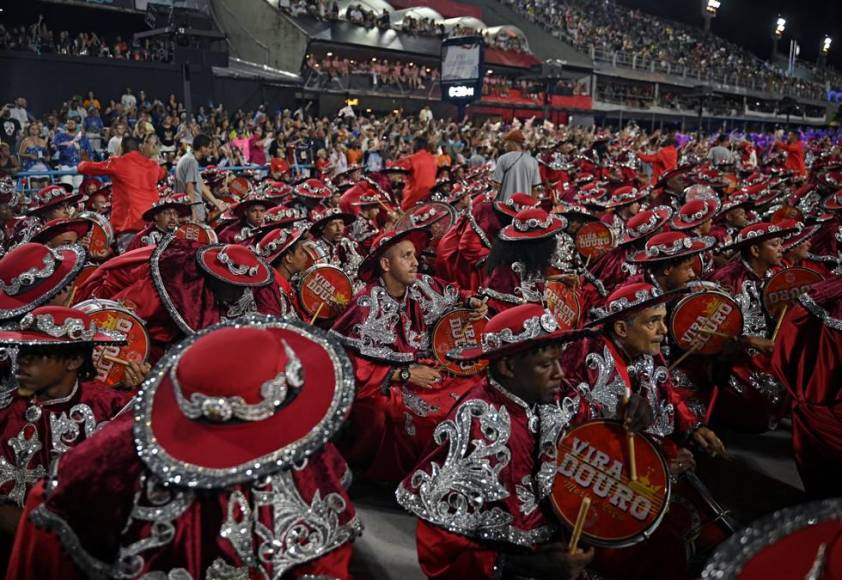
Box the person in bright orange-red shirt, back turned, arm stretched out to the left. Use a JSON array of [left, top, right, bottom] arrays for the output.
[[79, 136, 167, 252]]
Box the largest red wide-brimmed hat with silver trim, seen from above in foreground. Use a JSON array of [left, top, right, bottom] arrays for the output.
[[134, 315, 354, 489]]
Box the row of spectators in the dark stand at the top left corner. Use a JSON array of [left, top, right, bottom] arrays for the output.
[[0, 17, 173, 62]]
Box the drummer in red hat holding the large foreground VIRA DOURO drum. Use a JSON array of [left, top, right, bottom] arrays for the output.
[[396, 304, 648, 579]]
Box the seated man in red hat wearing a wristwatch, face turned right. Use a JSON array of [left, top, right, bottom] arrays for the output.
[[332, 229, 487, 481]]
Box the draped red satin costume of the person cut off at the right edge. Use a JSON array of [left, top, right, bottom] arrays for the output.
[[772, 276, 842, 497]]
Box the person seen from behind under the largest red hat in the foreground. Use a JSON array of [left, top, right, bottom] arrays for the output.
[[9, 316, 362, 580]]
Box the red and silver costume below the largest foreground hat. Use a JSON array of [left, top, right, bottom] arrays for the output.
[[7, 416, 361, 580]]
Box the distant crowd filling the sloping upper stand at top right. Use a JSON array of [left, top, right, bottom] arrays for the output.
[[505, 0, 824, 99]]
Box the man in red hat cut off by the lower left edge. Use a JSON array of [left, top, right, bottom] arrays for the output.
[[0, 306, 130, 535]]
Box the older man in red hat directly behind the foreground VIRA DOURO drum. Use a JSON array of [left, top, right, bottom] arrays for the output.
[[562, 283, 725, 578]]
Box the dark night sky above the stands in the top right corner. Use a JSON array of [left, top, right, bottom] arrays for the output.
[[619, 0, 842, 70]]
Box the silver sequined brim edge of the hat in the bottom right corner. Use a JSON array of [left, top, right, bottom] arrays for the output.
[[701, 498, 842, 580]]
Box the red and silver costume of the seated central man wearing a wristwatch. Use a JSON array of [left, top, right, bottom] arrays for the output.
[[333, 276, 482, 481]]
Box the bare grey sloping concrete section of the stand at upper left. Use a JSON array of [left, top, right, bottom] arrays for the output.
[[210, 0, 308, 74]]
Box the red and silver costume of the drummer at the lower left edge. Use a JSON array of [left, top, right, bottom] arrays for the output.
[[0, 381, 131, 507]]
